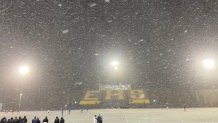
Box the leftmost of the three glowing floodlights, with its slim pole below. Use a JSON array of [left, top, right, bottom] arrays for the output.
[[18, 65, 30, 112]]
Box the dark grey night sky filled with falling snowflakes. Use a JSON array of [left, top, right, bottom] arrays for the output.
[[0, 0, 218, 107]]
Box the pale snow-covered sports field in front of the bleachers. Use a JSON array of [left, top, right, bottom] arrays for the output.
[[0, 108, 218, 123]]
